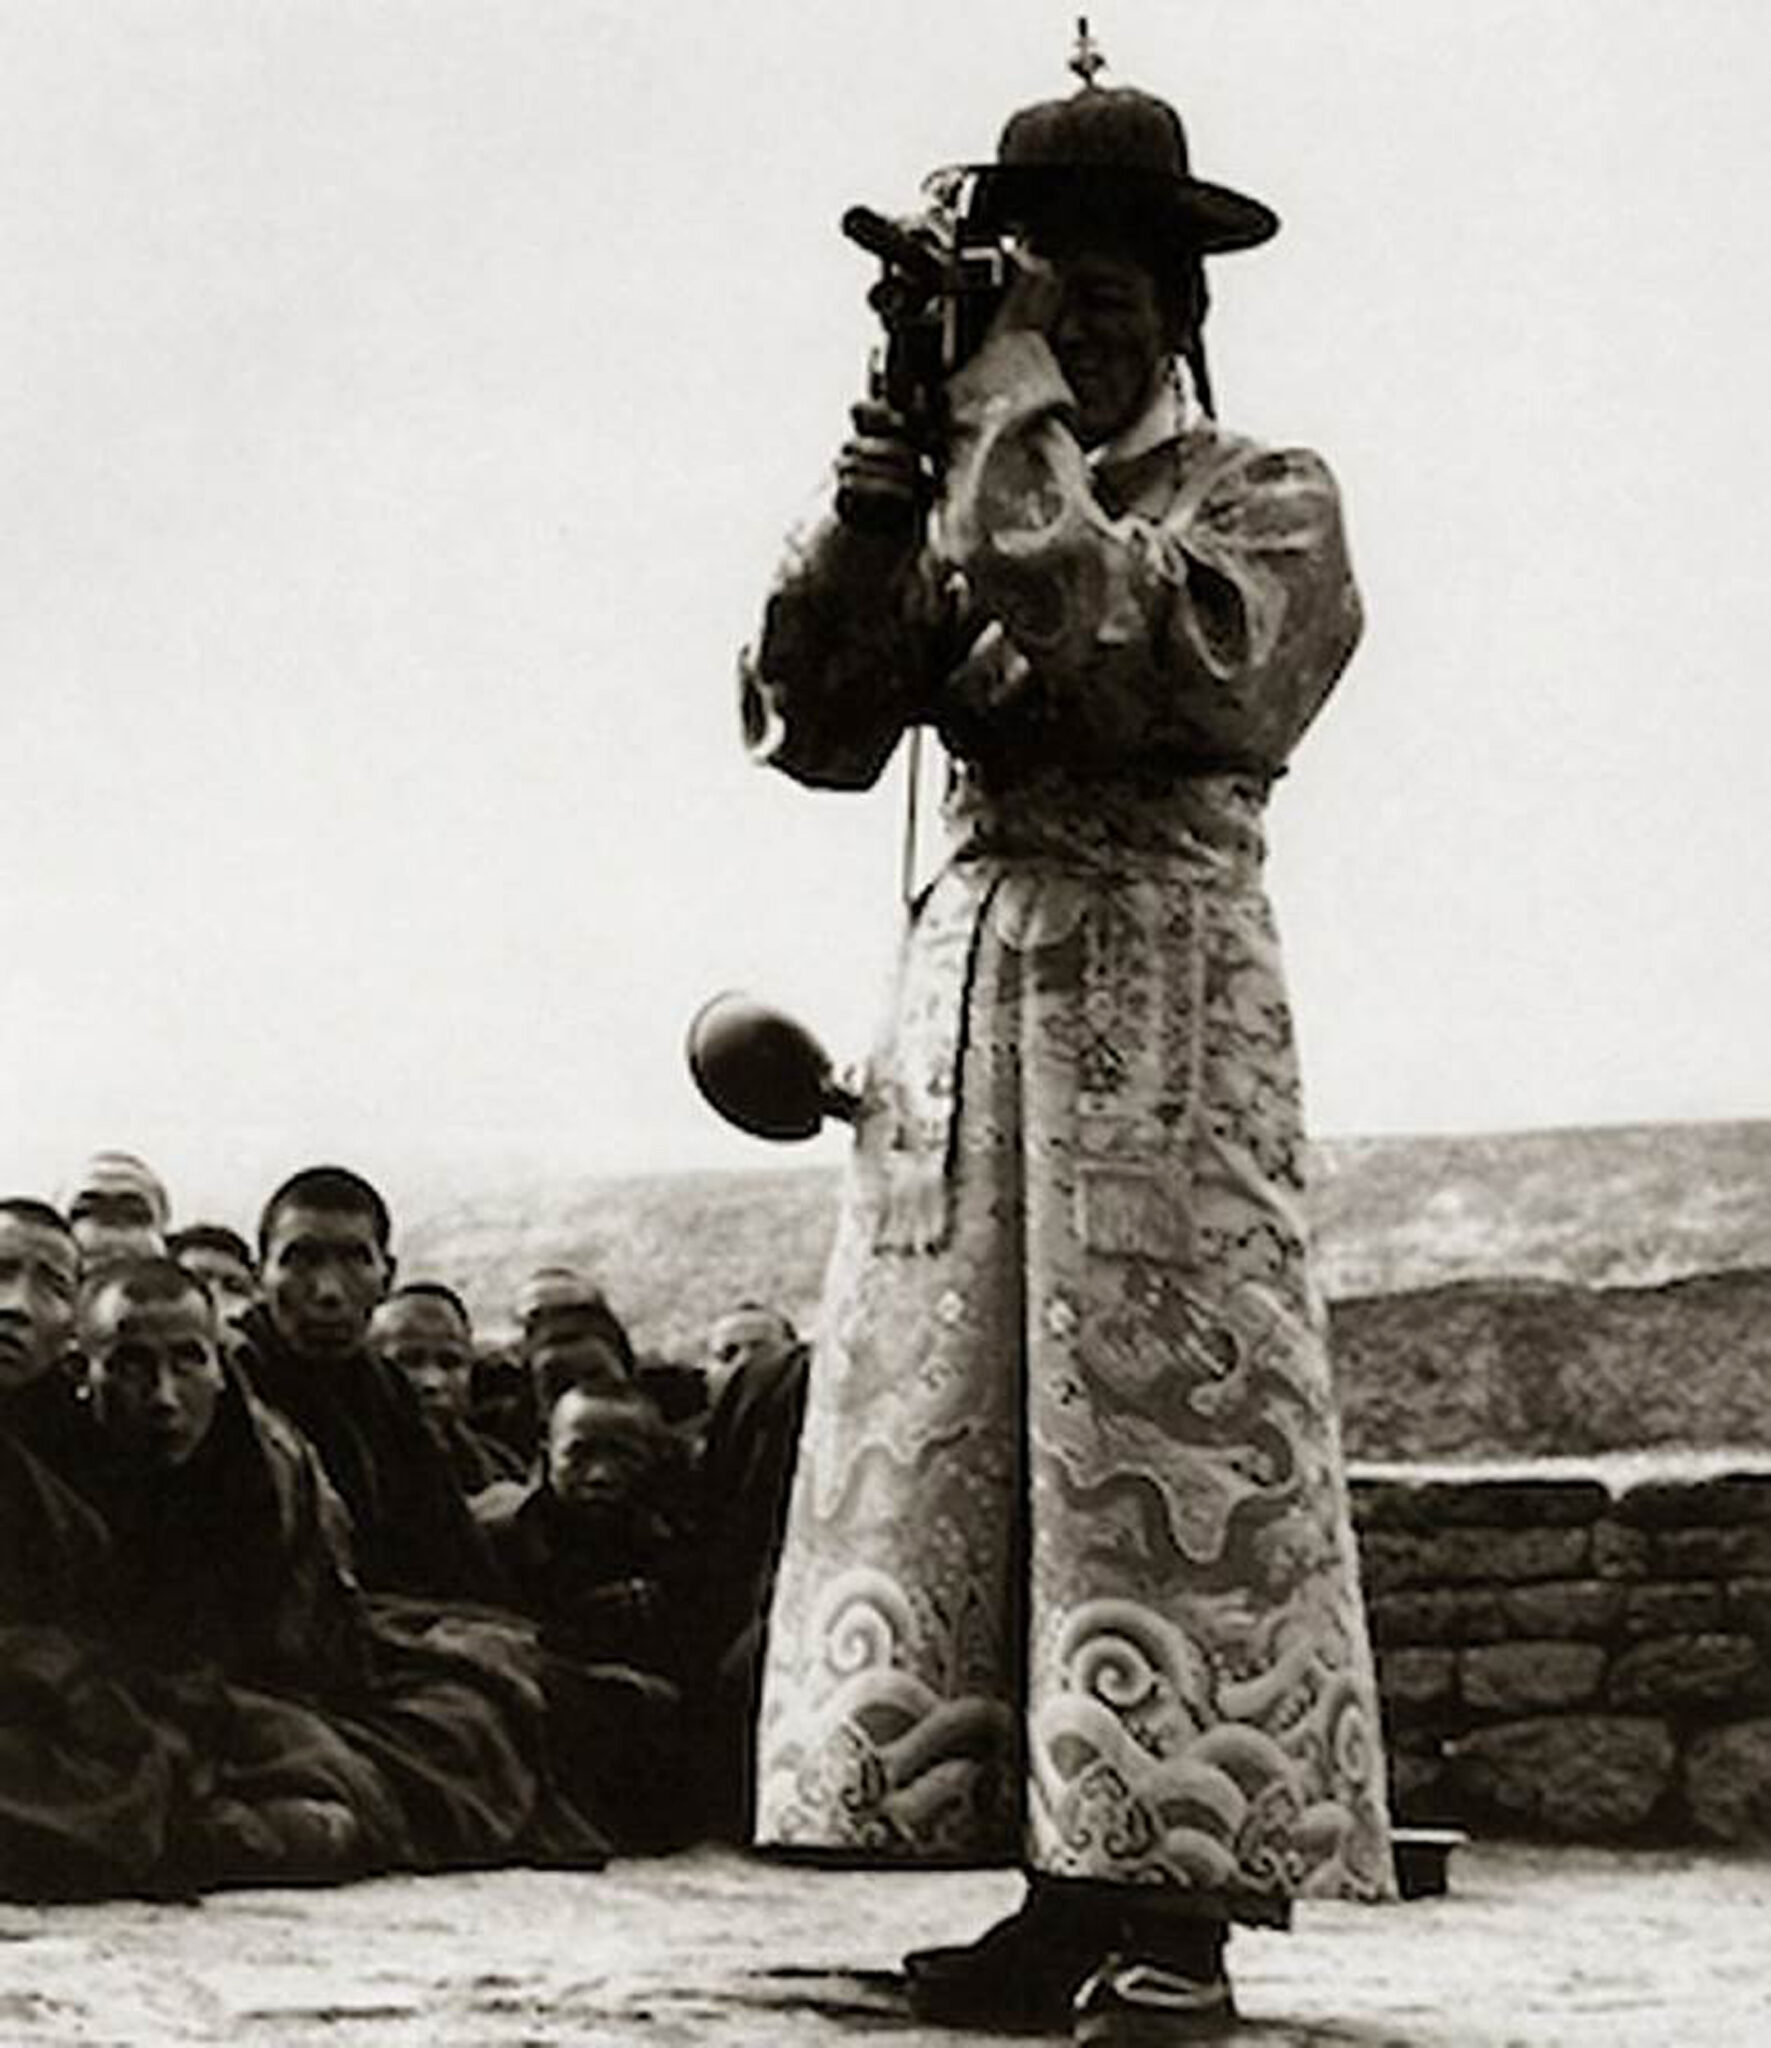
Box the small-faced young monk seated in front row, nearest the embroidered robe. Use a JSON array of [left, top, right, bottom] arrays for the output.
[[475, 1386, 688, 1849]]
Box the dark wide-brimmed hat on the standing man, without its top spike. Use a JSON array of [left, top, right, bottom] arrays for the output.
[[970, 82, 1280, 256]]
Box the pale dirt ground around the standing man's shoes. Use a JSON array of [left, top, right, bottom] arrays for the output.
[[0, 1843, 1771, 2048]]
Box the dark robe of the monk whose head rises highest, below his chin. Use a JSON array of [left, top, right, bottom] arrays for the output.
[[242, 1311, 498, 1599]]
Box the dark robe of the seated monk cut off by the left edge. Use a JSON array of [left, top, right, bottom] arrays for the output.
[[0, 1432, 192, 1898]]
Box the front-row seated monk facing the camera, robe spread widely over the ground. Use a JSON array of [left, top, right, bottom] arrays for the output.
[[80, 1262, 602, 1884]]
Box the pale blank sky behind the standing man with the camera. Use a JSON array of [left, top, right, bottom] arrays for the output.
[[0, 0, 1771, 1223]]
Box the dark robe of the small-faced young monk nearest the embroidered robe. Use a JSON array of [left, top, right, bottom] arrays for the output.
[[481, 1481, 696, 1849]]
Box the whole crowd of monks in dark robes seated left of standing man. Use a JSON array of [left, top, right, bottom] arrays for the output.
[[0, 1153, 805, 1898]]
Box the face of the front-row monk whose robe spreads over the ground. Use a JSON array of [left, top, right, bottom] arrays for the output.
[[82, 1282, 223, 1470]]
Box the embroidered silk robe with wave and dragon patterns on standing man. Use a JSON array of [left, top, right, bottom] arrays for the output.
[[741, 334, 1390, 1919]]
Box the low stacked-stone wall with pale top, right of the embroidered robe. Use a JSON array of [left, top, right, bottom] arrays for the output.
[[1353, 1456, 1771, 1843]]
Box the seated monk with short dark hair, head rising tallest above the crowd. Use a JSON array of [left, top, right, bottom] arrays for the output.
[[242, 1167, 498, 1599]]
